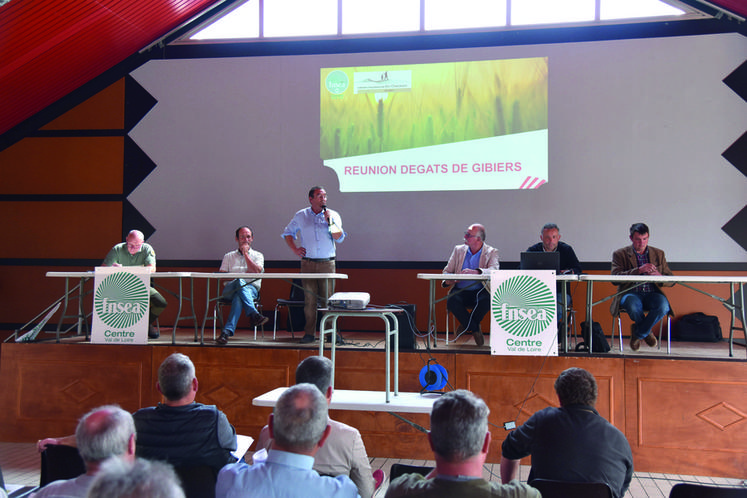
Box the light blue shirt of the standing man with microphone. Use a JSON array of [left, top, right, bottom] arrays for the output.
[[281, 207, 347, 259]]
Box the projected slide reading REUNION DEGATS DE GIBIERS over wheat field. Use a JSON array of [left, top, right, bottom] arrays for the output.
[[319, 57, 548, 192]]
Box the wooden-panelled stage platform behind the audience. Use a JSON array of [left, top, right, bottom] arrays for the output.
[[0, 327, 747, 477]]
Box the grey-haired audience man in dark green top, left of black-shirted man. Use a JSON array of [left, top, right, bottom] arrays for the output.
[[386, 389, 540, 498]]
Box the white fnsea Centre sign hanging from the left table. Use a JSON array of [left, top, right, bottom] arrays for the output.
[[91, 266, 150, 344]]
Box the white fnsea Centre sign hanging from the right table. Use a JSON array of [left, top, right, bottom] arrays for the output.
[[490, 270, 558, 356]]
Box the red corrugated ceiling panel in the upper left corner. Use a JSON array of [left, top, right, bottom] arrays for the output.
[[0, 0, 218, 138]]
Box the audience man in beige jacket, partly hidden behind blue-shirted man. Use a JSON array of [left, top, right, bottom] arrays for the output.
[[257, 356, 376, 498]]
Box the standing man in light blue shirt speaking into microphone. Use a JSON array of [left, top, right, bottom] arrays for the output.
[[282, 186, 346, 344]]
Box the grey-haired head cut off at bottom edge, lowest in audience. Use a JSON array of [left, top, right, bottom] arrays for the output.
[[88, 458, 184, 498]]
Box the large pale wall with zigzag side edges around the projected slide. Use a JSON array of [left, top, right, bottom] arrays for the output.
[[130, 34, 747, 262]]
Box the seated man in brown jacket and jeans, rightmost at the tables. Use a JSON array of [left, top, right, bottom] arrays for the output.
[[610, 223, 674, 351]]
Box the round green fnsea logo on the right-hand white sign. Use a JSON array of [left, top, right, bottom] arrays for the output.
[[492, 275, 555, 338]]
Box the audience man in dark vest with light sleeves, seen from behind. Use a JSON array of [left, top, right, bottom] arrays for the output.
[[133, 353, 236, 470]]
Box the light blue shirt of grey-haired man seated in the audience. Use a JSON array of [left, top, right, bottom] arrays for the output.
[[215, 449, 360, 498]]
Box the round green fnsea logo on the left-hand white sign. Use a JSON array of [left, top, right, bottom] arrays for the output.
[[93, 271, 149, 328]]
